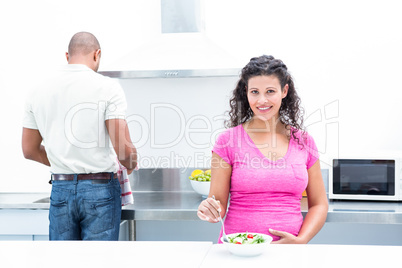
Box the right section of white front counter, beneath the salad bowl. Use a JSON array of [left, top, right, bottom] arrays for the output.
[[200, 244, 402, 268]]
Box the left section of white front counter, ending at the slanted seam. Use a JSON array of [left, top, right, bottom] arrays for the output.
[[0, 241, 212, 268]]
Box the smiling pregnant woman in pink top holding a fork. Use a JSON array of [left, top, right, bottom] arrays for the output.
[[197, 55, 328, 244]]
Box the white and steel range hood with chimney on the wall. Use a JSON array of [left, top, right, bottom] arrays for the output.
[[99, 0, 241, 79]]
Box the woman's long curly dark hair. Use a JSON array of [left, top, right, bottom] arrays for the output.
[[225, 55, 304, 143]]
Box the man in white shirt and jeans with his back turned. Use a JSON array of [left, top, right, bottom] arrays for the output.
[[22, 32, 137, 240]]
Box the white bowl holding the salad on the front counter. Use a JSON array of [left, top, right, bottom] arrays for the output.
[[221, 233, 272, 257]]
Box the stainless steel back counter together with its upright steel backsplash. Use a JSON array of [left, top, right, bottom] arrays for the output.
[[0, 168, 402, 224]]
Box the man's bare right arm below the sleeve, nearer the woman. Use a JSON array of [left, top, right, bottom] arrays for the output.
[[105, 119, 137, 174]]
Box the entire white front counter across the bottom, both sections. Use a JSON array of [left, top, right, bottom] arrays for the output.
[[0, 241, 402, 268]]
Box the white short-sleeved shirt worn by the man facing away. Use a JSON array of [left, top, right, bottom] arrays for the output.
[[23, 64, 127, 174]]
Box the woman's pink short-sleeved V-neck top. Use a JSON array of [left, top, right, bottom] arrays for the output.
[[212, 125, 318, 243]]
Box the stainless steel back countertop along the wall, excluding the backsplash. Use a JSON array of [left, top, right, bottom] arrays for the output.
[[0, 191, 402, 224]]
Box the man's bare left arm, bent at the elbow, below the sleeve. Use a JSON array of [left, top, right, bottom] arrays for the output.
[[22, 128, 50, 166]]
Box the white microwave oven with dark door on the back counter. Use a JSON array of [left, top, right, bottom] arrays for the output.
[[328, 158, 402, 201]]
